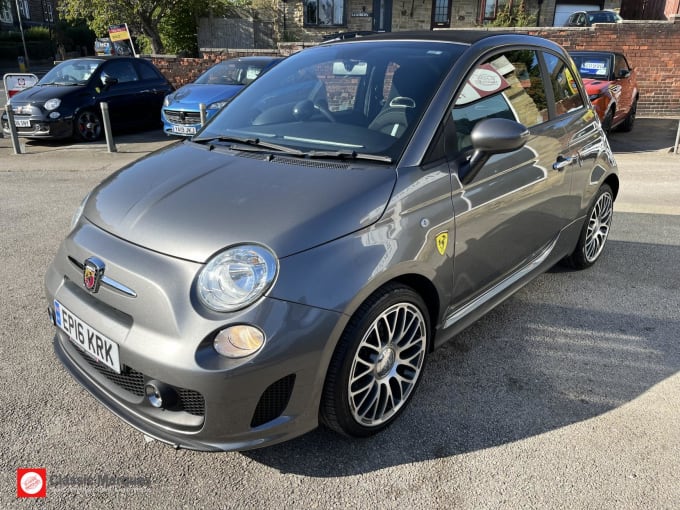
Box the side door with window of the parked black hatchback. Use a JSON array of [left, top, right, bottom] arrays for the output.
[[98, 58, 148, 126]]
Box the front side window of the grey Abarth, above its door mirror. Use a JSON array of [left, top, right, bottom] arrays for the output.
[[451, 50, 548, 151]]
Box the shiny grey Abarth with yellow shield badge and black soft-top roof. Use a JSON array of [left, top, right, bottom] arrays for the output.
[[46, 31, 619, 450]]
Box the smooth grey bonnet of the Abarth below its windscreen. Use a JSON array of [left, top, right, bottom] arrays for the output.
[[83, 142, 396, 262]]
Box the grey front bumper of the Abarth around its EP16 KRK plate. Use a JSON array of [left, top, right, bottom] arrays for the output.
[[46, 223, 340, 450]]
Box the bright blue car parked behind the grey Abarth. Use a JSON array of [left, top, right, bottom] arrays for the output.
[[161, 57, 283, 136]]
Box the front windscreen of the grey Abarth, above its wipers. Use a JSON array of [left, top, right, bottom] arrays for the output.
[[194, 41, 466, 159]]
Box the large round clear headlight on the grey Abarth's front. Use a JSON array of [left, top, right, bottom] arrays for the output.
[[197, 245, 278, 312]]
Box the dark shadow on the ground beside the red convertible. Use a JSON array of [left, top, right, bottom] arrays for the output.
[[608, 118, 680, 153]]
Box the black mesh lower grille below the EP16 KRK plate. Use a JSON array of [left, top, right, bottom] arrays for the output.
[[71, 343, 205, 416]]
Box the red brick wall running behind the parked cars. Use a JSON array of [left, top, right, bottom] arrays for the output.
[[151, 16, 680, 117]]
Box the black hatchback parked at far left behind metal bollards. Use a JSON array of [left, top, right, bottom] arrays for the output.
[[2, 57, 173, 141]]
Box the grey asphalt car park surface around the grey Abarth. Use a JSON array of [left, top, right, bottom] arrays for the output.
[[0, 118, 680, 509]]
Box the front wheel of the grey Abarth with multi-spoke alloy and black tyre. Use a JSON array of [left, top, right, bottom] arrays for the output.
[[320, 285, 431, 437]]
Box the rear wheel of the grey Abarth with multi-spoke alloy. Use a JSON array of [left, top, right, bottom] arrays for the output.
[[566, 184, 614, 269]]
